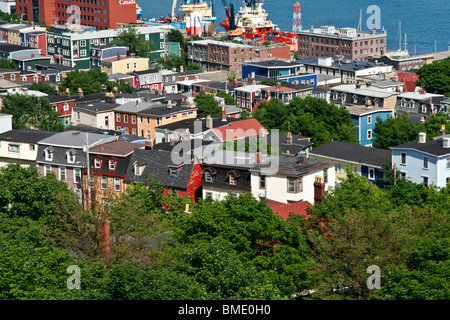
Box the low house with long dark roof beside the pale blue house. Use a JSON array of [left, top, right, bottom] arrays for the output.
[[310, 141, 392, 186]]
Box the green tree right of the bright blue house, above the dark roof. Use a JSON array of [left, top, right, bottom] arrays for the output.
[[373, 114, 422, 149]]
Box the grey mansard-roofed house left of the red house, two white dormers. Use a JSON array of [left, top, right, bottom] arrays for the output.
[[36, 131, 117, 201]]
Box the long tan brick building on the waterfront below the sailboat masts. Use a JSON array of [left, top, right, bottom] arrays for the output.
[[297, 26, 386, 61]]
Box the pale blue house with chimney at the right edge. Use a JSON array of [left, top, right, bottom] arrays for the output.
[[391, 132, 450, 187]]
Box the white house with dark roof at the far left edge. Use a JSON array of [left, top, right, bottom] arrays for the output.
[[0, 129, 55, 167]]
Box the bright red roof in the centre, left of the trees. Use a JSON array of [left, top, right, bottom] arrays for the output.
[[213, 119, 268, 141]]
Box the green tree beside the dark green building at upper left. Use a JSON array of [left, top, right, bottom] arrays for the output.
[[113, 26, 156, 58]]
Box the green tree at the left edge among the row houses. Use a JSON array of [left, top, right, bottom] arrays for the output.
[[2, 93, 64, 131]]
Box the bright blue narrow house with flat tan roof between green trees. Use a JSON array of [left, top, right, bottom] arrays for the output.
[[347, 105, 393, 147]]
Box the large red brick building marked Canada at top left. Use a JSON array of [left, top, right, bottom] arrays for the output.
[[16, 0, 137, 30]]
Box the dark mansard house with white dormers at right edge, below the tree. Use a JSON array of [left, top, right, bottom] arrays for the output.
[[395, 90, 448, 123]]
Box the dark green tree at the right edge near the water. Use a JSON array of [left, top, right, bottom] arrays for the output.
[[416, 58, 450, 97]]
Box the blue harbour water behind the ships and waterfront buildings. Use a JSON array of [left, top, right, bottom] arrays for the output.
[[137, 0, 450, 54]]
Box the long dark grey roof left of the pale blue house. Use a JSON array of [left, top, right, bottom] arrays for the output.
[[311, 141, 392, 168]]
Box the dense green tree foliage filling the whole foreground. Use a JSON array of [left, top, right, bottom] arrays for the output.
[[0, 165, 450, 300]]
